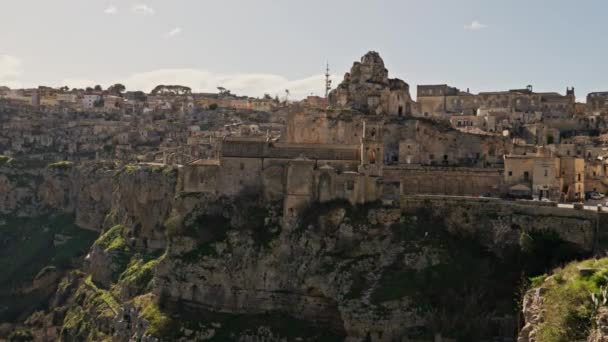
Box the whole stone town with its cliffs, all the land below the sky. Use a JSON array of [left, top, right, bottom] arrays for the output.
[[0, 51, 608, 342]]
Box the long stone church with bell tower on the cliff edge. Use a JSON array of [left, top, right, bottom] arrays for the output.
[[181, 127, 382, 214]]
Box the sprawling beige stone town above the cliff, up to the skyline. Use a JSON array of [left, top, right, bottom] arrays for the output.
[[0, 52, 608, 210]]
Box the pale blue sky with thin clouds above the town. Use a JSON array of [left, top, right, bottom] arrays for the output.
[[0, 0, 608, 101]]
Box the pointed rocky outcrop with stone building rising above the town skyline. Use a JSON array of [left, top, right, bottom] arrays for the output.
[[329, 51, 416, 116]]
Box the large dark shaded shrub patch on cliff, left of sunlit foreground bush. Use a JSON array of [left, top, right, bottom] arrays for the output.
[[360, 206, 581, 341]]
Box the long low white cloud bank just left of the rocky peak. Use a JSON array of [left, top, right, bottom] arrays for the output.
[[119, 69, 337, 100]]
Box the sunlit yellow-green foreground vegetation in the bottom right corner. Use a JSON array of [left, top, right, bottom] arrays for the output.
[[536, 258, 608, 342]]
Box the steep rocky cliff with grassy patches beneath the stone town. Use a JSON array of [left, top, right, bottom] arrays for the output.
[[0, 160, 601, 341]]
